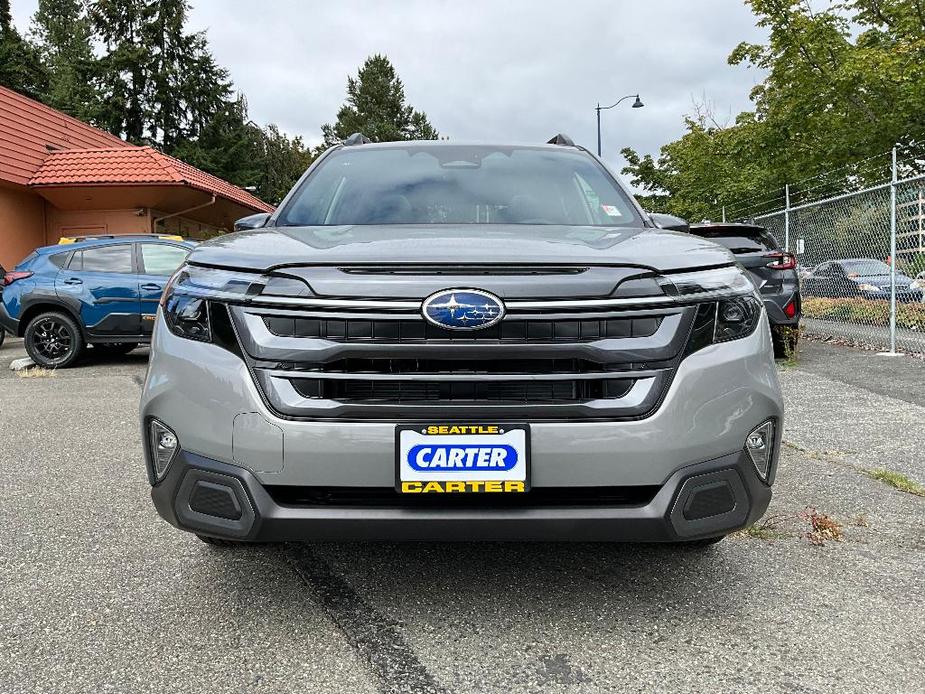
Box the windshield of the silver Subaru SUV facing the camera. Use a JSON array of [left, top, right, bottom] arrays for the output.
[[276, 144, 642, 227]]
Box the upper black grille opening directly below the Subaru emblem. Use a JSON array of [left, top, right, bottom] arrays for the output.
[[263, 316, 662, 344]]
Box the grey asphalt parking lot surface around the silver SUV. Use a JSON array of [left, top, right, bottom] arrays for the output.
[[0, 340, 925, 694]]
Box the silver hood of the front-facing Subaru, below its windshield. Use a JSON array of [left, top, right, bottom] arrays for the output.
[[189, 224, 735, 272]]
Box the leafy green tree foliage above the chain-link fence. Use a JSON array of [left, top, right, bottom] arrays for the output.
[[624, 0, 925, 219]]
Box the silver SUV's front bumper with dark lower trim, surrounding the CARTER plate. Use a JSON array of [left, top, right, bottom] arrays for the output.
[[141, 314, 783, 541]]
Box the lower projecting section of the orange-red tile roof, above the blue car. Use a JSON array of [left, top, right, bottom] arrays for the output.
[[29, 146, 273, 212]]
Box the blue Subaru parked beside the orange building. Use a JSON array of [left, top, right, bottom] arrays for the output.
[[0, 235, 195, 368]]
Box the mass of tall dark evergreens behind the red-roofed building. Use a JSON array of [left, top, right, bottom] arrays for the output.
[[0, 0, 320, 203]]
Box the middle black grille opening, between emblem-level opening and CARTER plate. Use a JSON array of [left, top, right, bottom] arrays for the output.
[[292, 378, 634, 405]]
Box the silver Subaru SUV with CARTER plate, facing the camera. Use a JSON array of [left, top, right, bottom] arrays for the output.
[[141, 136, 783, 545]]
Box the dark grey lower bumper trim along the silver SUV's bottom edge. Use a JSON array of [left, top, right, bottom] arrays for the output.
[[151, 452, 771, 542]]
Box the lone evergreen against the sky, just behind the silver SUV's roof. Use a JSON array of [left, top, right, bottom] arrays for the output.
[[321, 55, 439, 147]]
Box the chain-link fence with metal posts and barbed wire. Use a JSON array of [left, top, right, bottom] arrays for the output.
[[720, 151, 925, 353]]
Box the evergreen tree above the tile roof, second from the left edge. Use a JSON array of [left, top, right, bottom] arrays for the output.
[[32, 0, 99, 122]]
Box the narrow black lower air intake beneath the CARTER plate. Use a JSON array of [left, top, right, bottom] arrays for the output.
[[264, 486, 660, 509]]
